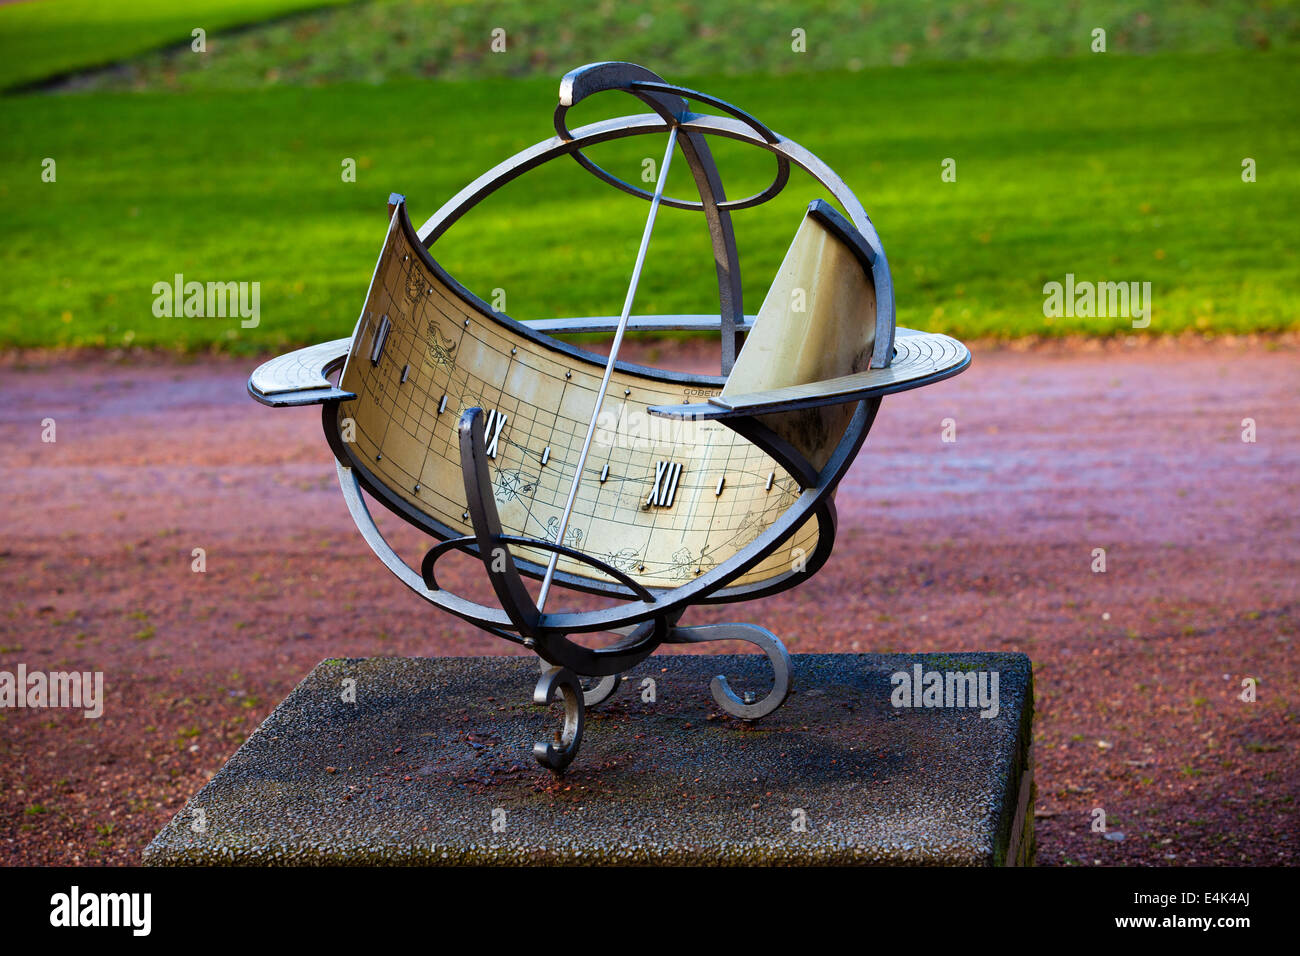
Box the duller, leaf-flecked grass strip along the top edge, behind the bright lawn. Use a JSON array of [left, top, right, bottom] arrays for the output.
[[45, 0, 1300, 90]]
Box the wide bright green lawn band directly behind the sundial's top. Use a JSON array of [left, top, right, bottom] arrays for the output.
[[0, 55, 1300, 351]]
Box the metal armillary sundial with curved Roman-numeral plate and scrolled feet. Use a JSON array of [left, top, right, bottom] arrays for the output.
[[248, 62, 970, 771]]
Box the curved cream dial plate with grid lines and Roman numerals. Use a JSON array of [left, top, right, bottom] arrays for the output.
[[338, 207, 818, 588]]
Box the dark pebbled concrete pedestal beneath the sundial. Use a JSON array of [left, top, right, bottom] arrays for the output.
[[144, 653, 1034, 865]]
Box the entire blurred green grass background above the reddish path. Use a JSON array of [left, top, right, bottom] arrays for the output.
[[0, 0, 1300, 352]]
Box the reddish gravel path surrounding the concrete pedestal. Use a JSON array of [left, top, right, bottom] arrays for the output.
[[0, 342, 1300, 865]]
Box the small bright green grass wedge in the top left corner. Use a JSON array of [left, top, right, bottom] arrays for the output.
[[0, 0, 353, 90]]
